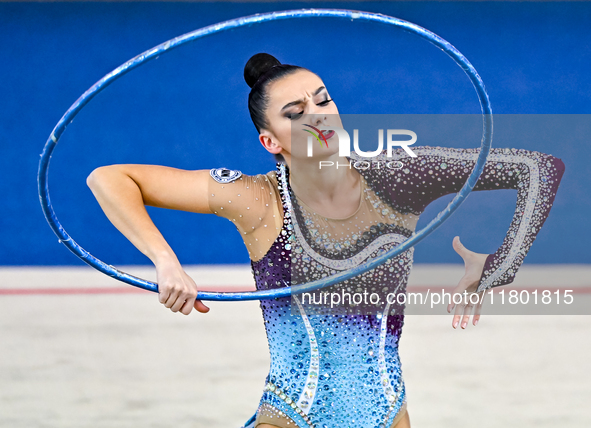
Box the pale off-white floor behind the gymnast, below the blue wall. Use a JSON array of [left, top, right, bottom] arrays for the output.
[[0, 266, 591, 428]]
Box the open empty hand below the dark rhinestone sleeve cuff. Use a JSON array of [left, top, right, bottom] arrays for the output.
[[447, 236, 488, 328]]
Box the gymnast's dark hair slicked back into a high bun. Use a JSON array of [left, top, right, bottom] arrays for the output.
[[244, 53, 307, 162]]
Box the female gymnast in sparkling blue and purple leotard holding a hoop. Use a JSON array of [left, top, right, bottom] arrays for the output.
[[87, 53, 564, 428]]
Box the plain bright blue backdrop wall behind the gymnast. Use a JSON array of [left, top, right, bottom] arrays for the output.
[[0, 2, 591, 265]]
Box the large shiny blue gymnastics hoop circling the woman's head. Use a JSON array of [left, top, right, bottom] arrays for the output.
[[37, 9, 492, 301]]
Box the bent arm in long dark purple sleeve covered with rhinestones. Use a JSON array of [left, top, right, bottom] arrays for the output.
[[374, 146, 564, 292]]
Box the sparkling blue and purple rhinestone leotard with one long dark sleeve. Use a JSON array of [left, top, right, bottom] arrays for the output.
[[210, 147, 564, 428]]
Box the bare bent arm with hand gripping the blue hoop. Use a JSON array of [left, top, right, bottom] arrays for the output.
[[87, 164, 264, 315]]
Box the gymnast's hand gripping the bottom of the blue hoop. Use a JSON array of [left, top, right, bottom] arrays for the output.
[[156, 262, 209, 315]]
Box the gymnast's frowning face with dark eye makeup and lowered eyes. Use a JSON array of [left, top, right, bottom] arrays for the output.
[[259, 70, 343, 166]]
